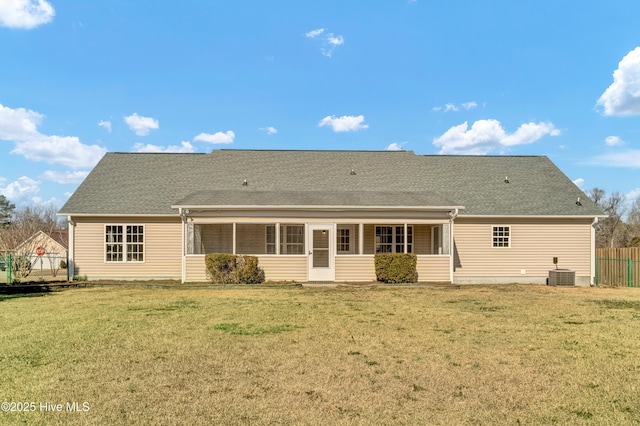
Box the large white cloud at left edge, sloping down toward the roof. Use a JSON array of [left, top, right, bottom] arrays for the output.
[[0, 104, 107, 168]]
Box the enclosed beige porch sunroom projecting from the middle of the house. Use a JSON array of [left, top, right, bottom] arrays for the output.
[[183, 212, 454, 282]]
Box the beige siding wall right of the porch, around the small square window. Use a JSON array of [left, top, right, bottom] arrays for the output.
[[454, 217, 591, 279]]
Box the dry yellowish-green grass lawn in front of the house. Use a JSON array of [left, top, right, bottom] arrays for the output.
[[0, 286, 640, 425]]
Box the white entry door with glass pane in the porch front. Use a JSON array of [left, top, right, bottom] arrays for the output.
[[308, 223, 336, 281]]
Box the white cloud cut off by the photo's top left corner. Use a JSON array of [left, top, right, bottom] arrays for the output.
[[0, 0, 56, 29]]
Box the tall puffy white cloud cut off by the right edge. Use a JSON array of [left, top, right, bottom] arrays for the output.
[[597, 47, 640, 116]]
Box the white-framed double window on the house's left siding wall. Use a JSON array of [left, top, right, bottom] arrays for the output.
[[104, 225, 144, 262]]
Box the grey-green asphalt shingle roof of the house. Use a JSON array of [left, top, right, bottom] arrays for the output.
[[60, 150, 602, 216]]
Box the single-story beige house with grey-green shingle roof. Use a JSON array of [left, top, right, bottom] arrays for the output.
[[59, 150, 604, 285]]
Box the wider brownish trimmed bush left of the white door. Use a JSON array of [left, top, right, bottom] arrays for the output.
[[205, 253, 264, 284]]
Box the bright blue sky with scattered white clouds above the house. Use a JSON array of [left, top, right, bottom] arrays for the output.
[[0, 0, 640, 206]]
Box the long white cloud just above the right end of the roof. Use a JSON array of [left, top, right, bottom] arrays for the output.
[[433, 120, 560, 155]]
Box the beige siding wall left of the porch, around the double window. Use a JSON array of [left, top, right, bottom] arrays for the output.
[[73, 217, 182, 280]]
